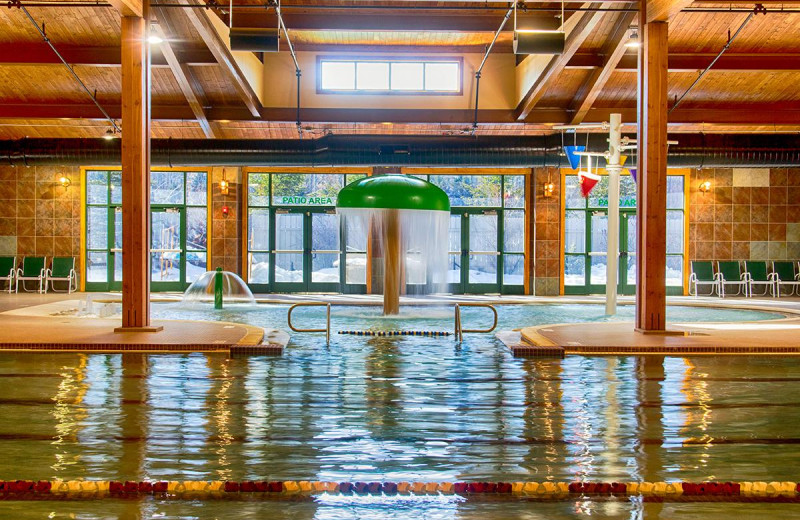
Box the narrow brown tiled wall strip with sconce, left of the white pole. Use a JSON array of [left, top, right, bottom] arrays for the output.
[[531, 168, 561, 296]]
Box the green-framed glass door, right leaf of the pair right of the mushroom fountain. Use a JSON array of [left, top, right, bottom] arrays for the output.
[[461, 210, 500, 293]]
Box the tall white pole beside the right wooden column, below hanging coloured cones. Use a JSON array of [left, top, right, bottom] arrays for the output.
[[606, 114, 622, 316]]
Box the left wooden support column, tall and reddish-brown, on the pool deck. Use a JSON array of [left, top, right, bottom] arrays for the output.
[[117, 8, 160, 331]]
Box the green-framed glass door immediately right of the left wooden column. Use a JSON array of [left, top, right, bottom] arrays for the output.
[[150, 208, 186, 291]]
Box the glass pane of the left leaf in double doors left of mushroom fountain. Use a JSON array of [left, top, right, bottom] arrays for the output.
[[275, 211, 305, 284]]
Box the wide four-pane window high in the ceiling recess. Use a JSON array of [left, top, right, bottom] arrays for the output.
[[319, 59, 461, 94]]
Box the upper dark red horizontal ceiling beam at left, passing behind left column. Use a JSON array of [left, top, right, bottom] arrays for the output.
[[0, 43, 217, 67]]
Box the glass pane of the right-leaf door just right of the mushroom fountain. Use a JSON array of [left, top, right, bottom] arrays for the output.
[[467, 212, 500, 292]]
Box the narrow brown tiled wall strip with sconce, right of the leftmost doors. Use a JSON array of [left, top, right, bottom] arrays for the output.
[[208, 167, 243, 275]]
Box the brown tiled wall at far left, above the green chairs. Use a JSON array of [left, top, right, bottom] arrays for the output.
[[0, 166, 82, 266]]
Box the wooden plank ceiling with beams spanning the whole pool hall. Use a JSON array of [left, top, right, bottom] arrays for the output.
[[0, 0, 800, 139]]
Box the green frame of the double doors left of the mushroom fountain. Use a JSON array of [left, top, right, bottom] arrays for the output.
[[269, 206, 345, 293]]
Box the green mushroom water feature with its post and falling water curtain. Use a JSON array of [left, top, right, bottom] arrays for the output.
[[336, 174, 450, 315]]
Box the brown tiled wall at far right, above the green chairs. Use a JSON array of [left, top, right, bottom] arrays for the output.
[[689, 168, 800, 260]]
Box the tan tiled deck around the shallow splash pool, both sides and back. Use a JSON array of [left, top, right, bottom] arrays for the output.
[[0, 293, 800, 356]]
